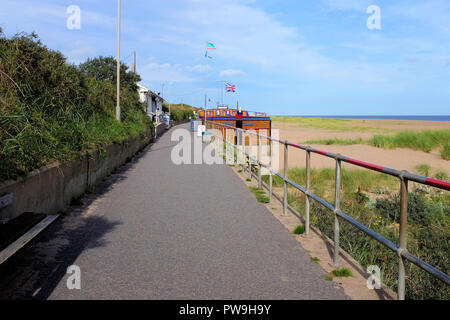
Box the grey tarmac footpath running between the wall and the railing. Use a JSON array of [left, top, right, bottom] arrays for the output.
[[0, 125, 348, 299]]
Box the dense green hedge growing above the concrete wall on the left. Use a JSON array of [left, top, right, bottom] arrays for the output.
[[0, 29, 152, 181]]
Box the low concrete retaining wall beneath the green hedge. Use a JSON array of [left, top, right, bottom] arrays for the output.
[[0, 130, 153, 223]]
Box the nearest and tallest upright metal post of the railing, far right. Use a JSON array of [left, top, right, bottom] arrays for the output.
[[397, 171, 408, 300]]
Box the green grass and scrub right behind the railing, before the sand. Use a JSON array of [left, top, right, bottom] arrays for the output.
[[263, 168, 450, 300]]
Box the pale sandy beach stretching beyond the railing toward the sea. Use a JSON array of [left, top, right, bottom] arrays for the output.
[[272, 119, 450, 175]]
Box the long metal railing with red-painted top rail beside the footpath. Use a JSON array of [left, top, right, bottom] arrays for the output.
[[207, 121, 450, 300]]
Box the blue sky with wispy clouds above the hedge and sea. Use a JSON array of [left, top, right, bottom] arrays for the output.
[[0, 0, 450, 115]]
